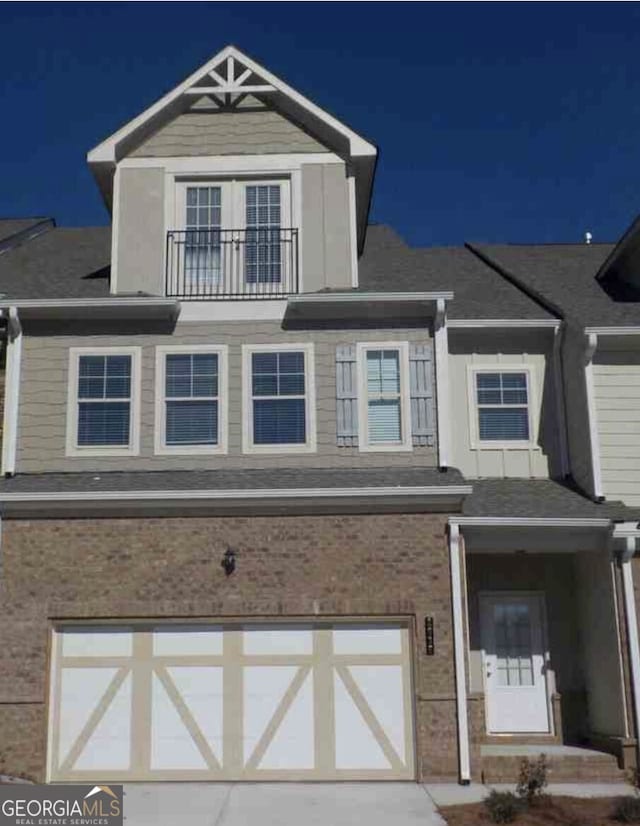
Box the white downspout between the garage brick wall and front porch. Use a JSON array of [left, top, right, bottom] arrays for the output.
[[449, 522, 471, 786]]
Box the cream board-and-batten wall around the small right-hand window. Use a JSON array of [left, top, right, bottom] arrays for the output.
[[449, 329, 560, 479]]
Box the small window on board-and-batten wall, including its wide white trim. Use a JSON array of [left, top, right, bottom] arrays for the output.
[[470, 366, 535, 448]]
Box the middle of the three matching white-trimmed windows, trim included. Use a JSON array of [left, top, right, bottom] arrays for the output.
[[155, 345, 227, 454]]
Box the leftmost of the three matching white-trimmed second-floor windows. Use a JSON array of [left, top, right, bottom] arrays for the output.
[[67, 347, 140, 456]]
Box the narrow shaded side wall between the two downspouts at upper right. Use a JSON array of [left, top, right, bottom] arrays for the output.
[[562, 327, 594, 495]]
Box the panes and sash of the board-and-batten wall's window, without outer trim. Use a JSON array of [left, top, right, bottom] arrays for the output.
[[475, 370, 531, 442]]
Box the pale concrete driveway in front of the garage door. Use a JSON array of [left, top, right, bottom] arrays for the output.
[[124, 783, 444, 826]]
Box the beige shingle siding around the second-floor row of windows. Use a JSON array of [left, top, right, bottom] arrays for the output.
[[18, 322, 436, 473]]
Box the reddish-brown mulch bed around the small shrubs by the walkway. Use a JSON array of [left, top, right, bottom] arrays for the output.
[[440, 797, 632, 826]]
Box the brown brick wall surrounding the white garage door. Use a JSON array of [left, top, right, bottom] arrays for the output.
[[0, 514, 458, 779]]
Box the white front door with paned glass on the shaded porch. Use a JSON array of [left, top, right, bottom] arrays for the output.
[[480, 594, 549, 734]]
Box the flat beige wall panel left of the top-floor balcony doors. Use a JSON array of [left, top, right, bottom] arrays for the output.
[[116, 168, 165, 295]]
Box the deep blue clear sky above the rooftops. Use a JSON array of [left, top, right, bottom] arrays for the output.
[[0, 2, 640, 245]]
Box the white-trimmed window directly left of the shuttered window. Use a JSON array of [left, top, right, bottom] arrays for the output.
[[243, 344, 316, 453]]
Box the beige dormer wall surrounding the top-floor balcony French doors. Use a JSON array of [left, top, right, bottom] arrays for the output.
[[114, 110, 356, 294]]
